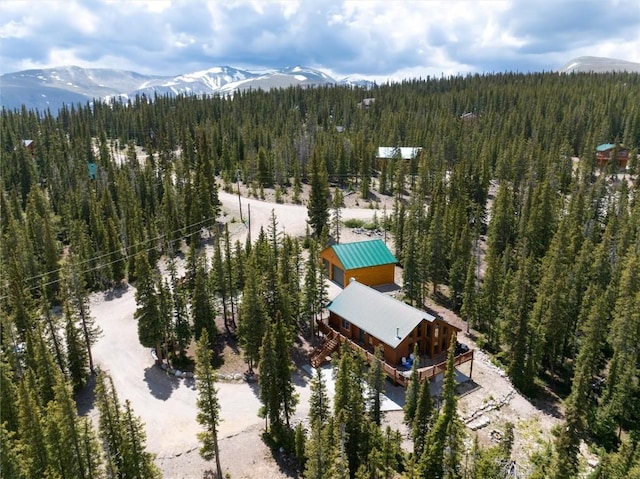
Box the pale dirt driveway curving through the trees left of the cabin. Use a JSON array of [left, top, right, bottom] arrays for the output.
[[89, 192, 384, 478]]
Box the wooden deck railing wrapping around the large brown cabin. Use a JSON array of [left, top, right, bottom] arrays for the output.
[[310, 321, 473, 387]]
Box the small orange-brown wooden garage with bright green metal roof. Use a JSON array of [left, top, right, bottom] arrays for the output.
[[320, 239, 398, 288]]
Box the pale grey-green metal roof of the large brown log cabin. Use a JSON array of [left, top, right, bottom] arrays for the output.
[[327, 281, 436, 348]]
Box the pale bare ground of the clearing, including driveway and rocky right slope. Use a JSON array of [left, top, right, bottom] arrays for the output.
[[84, 192, 558, 479]]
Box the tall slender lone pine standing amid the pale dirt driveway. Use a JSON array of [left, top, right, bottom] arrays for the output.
[[196, 329, 222, 477]]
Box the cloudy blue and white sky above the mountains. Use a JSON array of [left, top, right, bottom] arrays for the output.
[[0, 0, 640, 81]]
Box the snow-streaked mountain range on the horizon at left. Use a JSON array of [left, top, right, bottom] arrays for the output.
[[0, 66, 373, 113]]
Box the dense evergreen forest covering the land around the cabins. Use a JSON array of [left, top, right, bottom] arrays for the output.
[[0, 73, 640, 479]]
